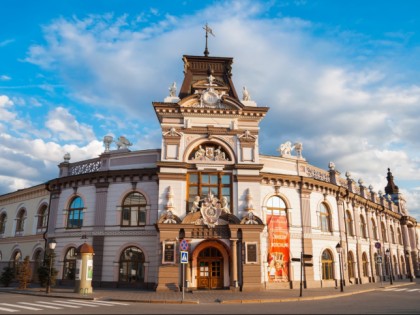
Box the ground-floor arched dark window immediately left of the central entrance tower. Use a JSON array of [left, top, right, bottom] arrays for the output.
[[118, 246, 144, 284]]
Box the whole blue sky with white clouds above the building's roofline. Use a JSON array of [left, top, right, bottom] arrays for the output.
[[0, 0, 420, 220]]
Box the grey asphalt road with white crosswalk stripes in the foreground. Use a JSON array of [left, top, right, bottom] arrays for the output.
[[0, 284, 420, 315]]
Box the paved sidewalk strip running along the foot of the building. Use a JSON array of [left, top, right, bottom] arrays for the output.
[[0, 280, 416, 304]]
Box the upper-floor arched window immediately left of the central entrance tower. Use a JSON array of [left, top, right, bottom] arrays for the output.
[[121, 192, 147, 226]]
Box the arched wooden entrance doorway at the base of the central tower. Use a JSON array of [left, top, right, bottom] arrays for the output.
[[197, 246, 224, 290]]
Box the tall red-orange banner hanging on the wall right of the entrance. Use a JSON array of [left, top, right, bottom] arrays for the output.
[[267, 214, 290, 282]]
